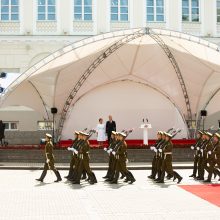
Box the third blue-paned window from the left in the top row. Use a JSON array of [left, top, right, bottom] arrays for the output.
[[74, 0, 92, 21]]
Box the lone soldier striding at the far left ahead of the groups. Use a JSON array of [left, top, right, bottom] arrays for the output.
[[36, 134, 62, 182]]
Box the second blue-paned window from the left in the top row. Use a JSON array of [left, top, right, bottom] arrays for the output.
[[37, 0, 56, 21]]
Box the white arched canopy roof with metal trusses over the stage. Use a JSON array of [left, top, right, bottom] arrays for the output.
[[1, 28, 220, 138]]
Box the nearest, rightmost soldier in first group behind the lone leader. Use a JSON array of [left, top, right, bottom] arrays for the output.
[[73, 132, 97, 184]]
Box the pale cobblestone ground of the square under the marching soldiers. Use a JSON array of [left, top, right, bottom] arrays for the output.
[[0, 170, 220, 220]]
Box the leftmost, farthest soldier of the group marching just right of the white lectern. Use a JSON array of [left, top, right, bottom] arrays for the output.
[[148, 131, 163, 179]]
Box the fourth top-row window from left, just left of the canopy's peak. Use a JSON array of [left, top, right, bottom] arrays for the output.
[[111, 0, 128, 21]]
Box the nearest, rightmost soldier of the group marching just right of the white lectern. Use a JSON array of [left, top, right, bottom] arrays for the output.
[[157, 133, 183, 183]]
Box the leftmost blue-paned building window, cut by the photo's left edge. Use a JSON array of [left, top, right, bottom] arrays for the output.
[[0, 0, 19, 21]]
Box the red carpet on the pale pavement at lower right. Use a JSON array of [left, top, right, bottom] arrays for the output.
[[179, 184, 220, 207]]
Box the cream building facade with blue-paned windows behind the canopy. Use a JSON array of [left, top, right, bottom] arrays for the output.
[[0, 0, 220, 143]]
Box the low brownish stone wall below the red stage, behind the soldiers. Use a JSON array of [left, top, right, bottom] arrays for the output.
[[0, 148, 193, 163]]
